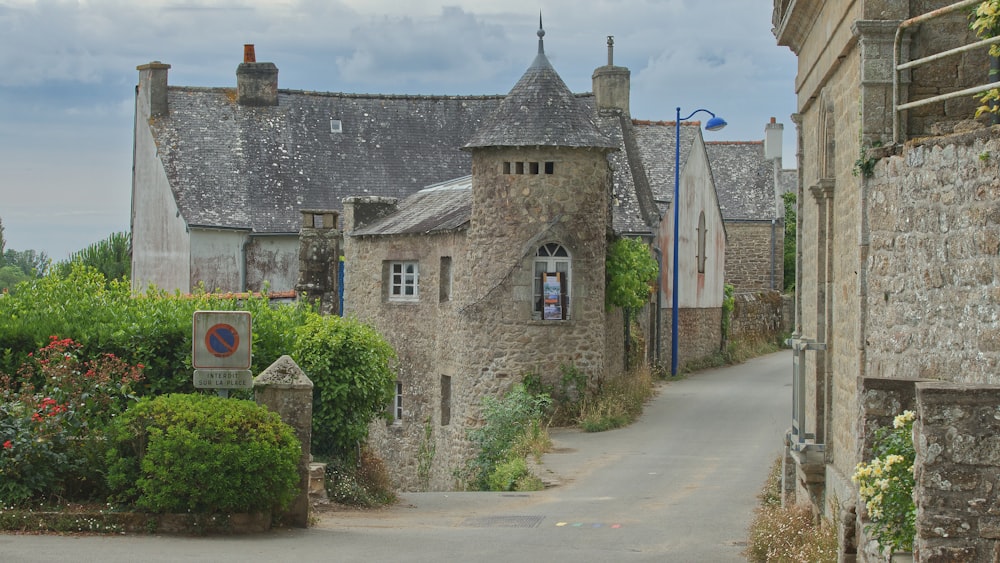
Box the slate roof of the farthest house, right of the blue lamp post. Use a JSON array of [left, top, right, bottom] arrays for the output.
[[705, 141, 777, 221]]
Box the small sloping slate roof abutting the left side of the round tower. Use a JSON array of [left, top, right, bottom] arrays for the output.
[[350, 176, 472, 236]]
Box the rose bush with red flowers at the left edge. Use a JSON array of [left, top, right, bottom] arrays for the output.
[[0, 336, 143, 506]]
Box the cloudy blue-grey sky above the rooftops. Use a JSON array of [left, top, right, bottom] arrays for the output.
[[0, 0, 795, 260]]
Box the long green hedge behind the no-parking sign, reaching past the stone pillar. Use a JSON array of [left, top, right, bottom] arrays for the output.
[[0, 264, 394, 457]]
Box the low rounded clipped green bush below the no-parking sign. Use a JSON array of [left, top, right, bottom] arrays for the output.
[[108, 394, 301, 513]]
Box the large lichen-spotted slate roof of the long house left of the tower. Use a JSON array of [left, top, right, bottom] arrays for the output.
[[151, 87, 502, 233]]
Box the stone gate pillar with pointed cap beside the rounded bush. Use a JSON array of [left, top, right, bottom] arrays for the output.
[[253, 356, 313, 528]]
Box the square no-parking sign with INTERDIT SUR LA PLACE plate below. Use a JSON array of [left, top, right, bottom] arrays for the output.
[[191, 311, 253, 397]]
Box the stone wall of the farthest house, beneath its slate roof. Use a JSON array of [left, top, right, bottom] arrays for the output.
[[726, 219, 785, 293]]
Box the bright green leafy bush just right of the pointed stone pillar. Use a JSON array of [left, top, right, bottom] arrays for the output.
[[292, 315, 396, 461]]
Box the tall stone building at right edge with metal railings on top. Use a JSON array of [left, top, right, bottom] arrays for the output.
[[773, 0, 1000, 561]]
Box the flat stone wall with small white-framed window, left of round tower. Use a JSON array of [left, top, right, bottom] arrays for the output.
[[344, 233, 468, 490]]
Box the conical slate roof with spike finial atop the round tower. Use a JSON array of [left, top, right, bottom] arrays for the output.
[[463, 21, 617, 149]]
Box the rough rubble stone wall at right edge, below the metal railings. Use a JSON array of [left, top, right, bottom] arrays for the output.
[[865, 127, 1000, 384]]
